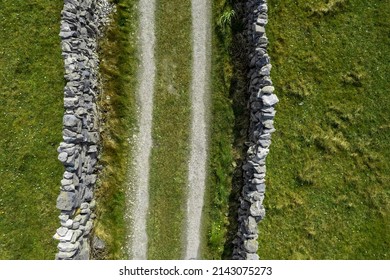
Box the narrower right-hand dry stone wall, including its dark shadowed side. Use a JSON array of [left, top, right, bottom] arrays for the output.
[[233, 0, 279, 260]]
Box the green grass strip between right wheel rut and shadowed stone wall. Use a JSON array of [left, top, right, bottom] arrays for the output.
[[202, 0, 247, 259]]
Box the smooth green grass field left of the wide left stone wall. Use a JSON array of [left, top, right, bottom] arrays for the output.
[[0, 0, 64, 259]]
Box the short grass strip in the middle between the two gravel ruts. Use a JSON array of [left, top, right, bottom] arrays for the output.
[[147, 0, 192, 259]]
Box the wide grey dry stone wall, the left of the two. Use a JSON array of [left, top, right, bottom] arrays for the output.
[[54, 0, 109, 259]]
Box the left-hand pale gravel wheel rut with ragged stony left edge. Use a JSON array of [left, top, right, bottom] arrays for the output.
[[128, 0, 156, 260]]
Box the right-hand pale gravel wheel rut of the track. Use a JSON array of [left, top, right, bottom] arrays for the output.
[[185, 0, 210, 259]]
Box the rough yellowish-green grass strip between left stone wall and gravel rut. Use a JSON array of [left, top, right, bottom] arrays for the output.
[[95, 0, 138, 259]]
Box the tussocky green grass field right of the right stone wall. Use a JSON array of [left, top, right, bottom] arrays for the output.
[[259, 0, 390, 259]]
